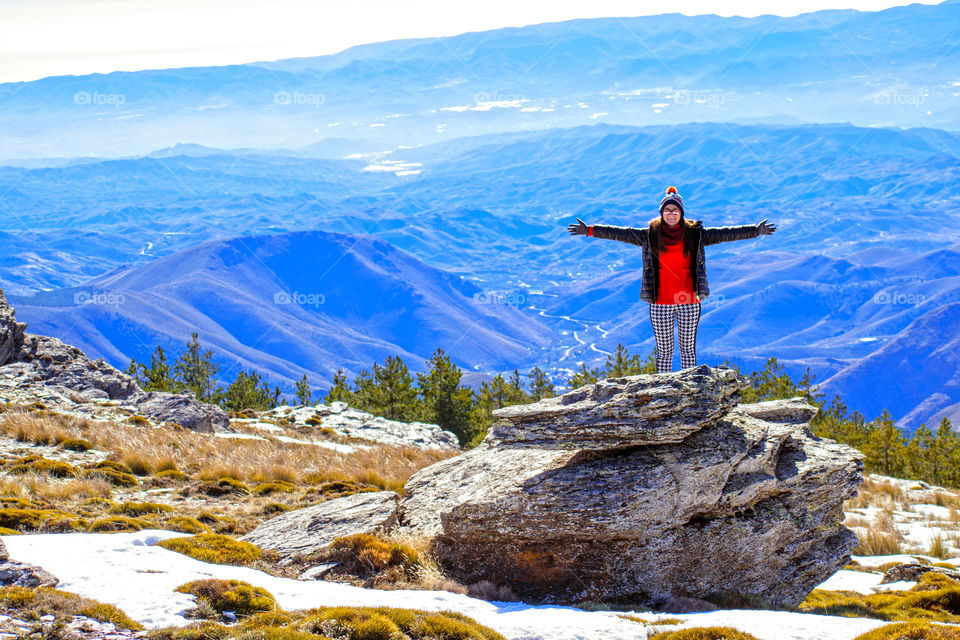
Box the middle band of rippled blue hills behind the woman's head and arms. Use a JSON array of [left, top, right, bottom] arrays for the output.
[[0, 123, 960, 294]]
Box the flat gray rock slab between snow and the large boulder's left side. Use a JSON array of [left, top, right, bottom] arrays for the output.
[[240, 491, 400, 558]]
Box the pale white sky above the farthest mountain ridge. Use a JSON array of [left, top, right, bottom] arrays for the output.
[[0, 0, 941, 83]]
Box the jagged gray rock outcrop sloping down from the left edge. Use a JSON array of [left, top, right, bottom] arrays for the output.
[[0, 290, 230, 432]]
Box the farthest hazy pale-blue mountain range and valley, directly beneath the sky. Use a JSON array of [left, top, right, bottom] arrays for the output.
[[0, 2, 960, 159]]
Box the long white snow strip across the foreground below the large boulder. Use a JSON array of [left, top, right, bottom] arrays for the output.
[[0, 530, 900, 640]]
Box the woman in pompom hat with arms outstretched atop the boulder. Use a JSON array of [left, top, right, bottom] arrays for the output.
[[567, 187, 777, 373]]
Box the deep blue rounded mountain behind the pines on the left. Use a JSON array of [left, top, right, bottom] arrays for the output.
[[9, 231, 553, 390]]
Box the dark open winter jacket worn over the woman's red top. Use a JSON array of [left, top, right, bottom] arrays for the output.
[[592, 218, 760, 303]]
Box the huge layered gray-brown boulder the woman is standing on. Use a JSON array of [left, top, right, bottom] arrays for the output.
[[400, 365, 863, 608]]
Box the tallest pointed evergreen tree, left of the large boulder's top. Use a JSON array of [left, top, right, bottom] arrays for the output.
[[417, 348, 477, 446]]
